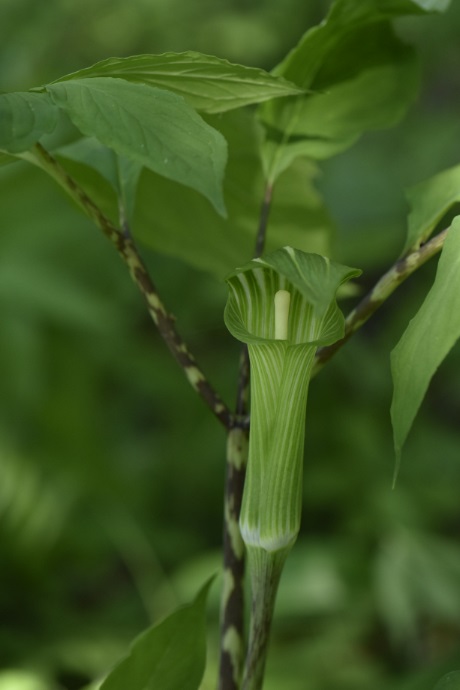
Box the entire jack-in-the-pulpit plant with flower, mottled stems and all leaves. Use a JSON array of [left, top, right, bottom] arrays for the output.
[[0, 0, 460, 690]]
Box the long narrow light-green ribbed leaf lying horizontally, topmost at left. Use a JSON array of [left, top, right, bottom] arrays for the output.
[[49, 52, 302, 113]]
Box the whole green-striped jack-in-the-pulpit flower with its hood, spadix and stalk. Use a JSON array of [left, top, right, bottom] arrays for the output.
[[225, 247, 360, 690]]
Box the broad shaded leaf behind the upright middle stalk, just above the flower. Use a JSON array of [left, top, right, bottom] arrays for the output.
[[56, 110, 332, 278]]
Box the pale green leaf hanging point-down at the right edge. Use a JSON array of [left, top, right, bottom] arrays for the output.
[[391, 217, 460, 467]]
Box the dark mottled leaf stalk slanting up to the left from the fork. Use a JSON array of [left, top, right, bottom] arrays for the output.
[[30, 144, 234, 429]]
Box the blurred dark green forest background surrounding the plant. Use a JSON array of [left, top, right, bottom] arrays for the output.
[[0, 0, 460, 690]]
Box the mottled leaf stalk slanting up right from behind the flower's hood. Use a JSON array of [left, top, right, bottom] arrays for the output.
[[313, 228, 448, 376]]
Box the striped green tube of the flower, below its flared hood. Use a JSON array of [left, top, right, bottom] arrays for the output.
[[244, 342, 316, 551]]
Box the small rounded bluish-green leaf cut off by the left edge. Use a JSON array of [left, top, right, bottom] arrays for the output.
[[0, 92, 59, 153]]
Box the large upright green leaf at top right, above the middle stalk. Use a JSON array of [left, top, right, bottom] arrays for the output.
[[261, 0, 446, 179]]
